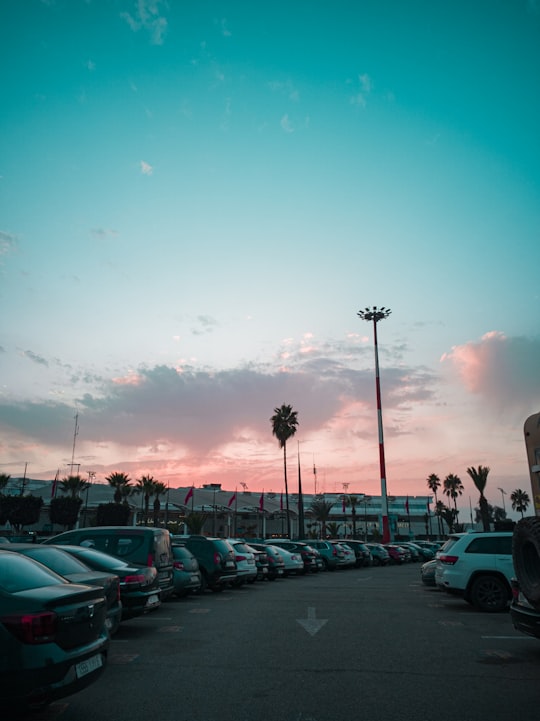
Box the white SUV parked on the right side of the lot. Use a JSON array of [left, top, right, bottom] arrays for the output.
[[435, 531, 515, 611]]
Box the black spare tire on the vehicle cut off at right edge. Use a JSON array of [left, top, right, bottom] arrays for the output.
[[512, 516, 540, 610]]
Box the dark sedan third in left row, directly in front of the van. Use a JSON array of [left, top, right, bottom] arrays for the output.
[[52, 545, 161, 620]]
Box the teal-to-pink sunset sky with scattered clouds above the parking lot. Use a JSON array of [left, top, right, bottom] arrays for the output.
[[0, 0, 540, 510]]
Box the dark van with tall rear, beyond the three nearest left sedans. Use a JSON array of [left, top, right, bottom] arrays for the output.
[[44, 526, 174, 601]]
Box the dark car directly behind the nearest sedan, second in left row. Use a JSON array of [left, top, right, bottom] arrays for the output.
[[0, 543, 122, 636]]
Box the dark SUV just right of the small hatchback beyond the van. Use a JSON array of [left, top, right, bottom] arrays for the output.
[[173, 534, 238, 591]]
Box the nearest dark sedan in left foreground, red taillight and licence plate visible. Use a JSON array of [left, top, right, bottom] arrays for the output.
[[0, 550, 109, 708]]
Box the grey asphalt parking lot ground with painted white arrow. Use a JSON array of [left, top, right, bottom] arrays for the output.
[[26, 564, 540, 721]]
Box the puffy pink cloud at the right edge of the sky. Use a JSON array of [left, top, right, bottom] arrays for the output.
[[441, 331, 540, 418]]
